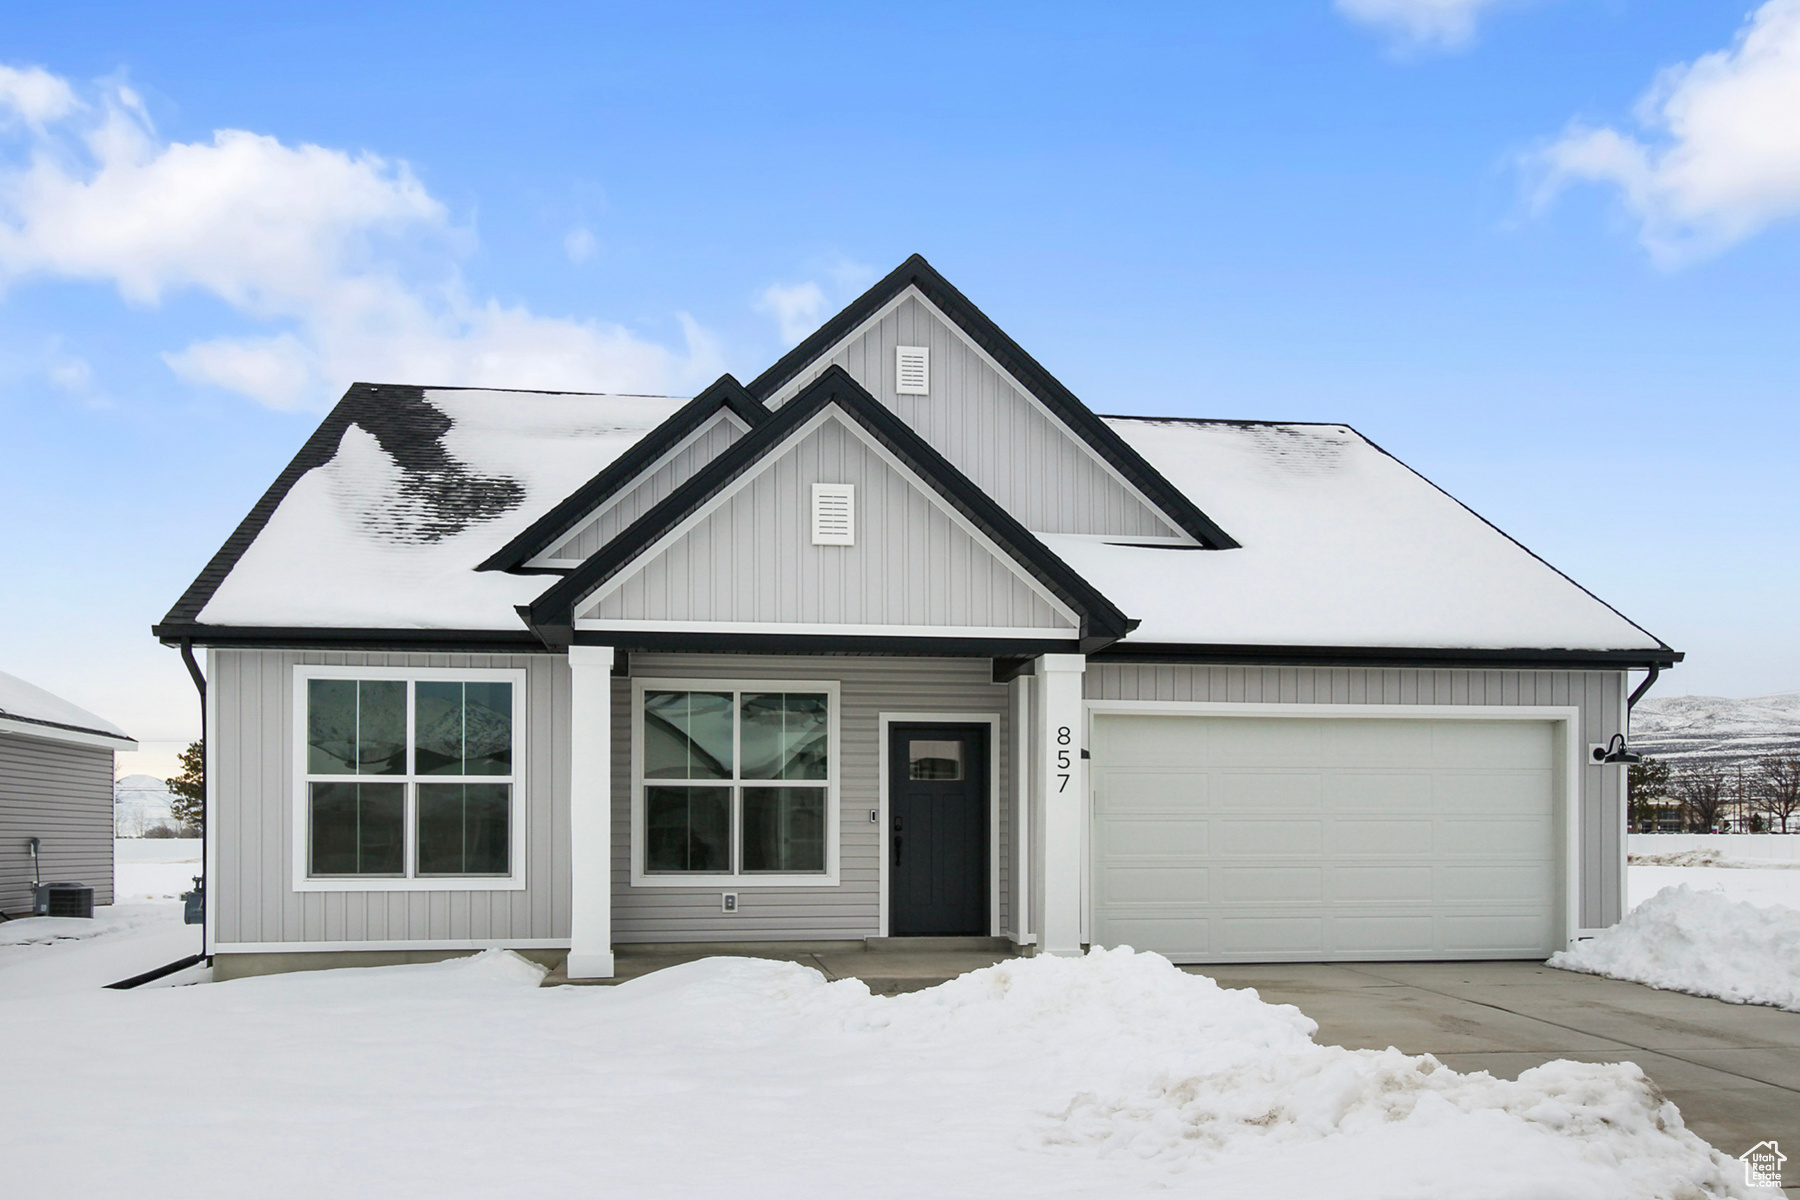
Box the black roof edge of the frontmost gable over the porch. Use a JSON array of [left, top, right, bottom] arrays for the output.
[[520, 367, 1132, 646]]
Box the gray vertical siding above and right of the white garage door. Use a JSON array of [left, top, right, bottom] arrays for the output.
[[1085, 662, 1625, 928]]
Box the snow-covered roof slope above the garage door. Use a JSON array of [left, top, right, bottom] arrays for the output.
[[1044, 417, 1661, 651]]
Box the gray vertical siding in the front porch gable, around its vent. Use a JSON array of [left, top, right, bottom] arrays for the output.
[[578, 412, 1076, 633]]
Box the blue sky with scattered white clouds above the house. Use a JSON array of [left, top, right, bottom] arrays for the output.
[[0, 0, 1800, 766]]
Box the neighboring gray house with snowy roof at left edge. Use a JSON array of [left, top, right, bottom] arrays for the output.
[[0, 671, 137, 916]]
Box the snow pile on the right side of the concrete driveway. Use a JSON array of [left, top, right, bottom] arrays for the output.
[[1550, 883, 1800, 1013]]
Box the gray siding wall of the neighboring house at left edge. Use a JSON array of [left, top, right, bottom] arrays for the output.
[[0, 732, 113, 916]]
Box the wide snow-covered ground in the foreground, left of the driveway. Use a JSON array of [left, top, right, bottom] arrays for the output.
[[0, 952, 1744, 1200]]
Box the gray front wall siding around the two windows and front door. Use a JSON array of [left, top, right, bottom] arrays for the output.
[[210, 649, 1012, 954]]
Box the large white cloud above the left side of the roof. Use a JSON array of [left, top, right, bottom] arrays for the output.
[[0, 76, 720, 408]]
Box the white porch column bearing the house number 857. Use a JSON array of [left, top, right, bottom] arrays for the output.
[[1031, 655, 1087, 955]]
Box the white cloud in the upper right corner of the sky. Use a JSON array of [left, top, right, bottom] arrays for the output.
[[1532, 0, 1800, 266]]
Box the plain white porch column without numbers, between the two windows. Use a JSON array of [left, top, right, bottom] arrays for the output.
[[569, 646, 612, 979]]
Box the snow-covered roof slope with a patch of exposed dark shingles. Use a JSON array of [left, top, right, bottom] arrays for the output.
[[198, 389, 684, 633]]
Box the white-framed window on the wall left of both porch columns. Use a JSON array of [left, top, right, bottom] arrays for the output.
[[293, 667, 524, 891]]
